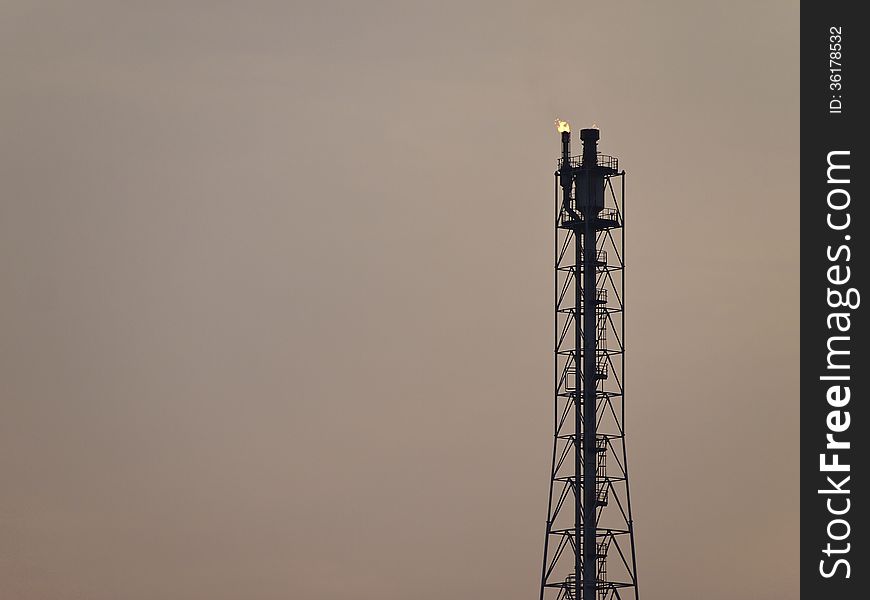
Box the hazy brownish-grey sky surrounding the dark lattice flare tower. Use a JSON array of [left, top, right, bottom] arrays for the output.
[[0, 0, 799, 600]]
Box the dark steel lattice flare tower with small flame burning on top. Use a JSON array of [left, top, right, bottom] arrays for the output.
[[540, 121, 637, 600]]
